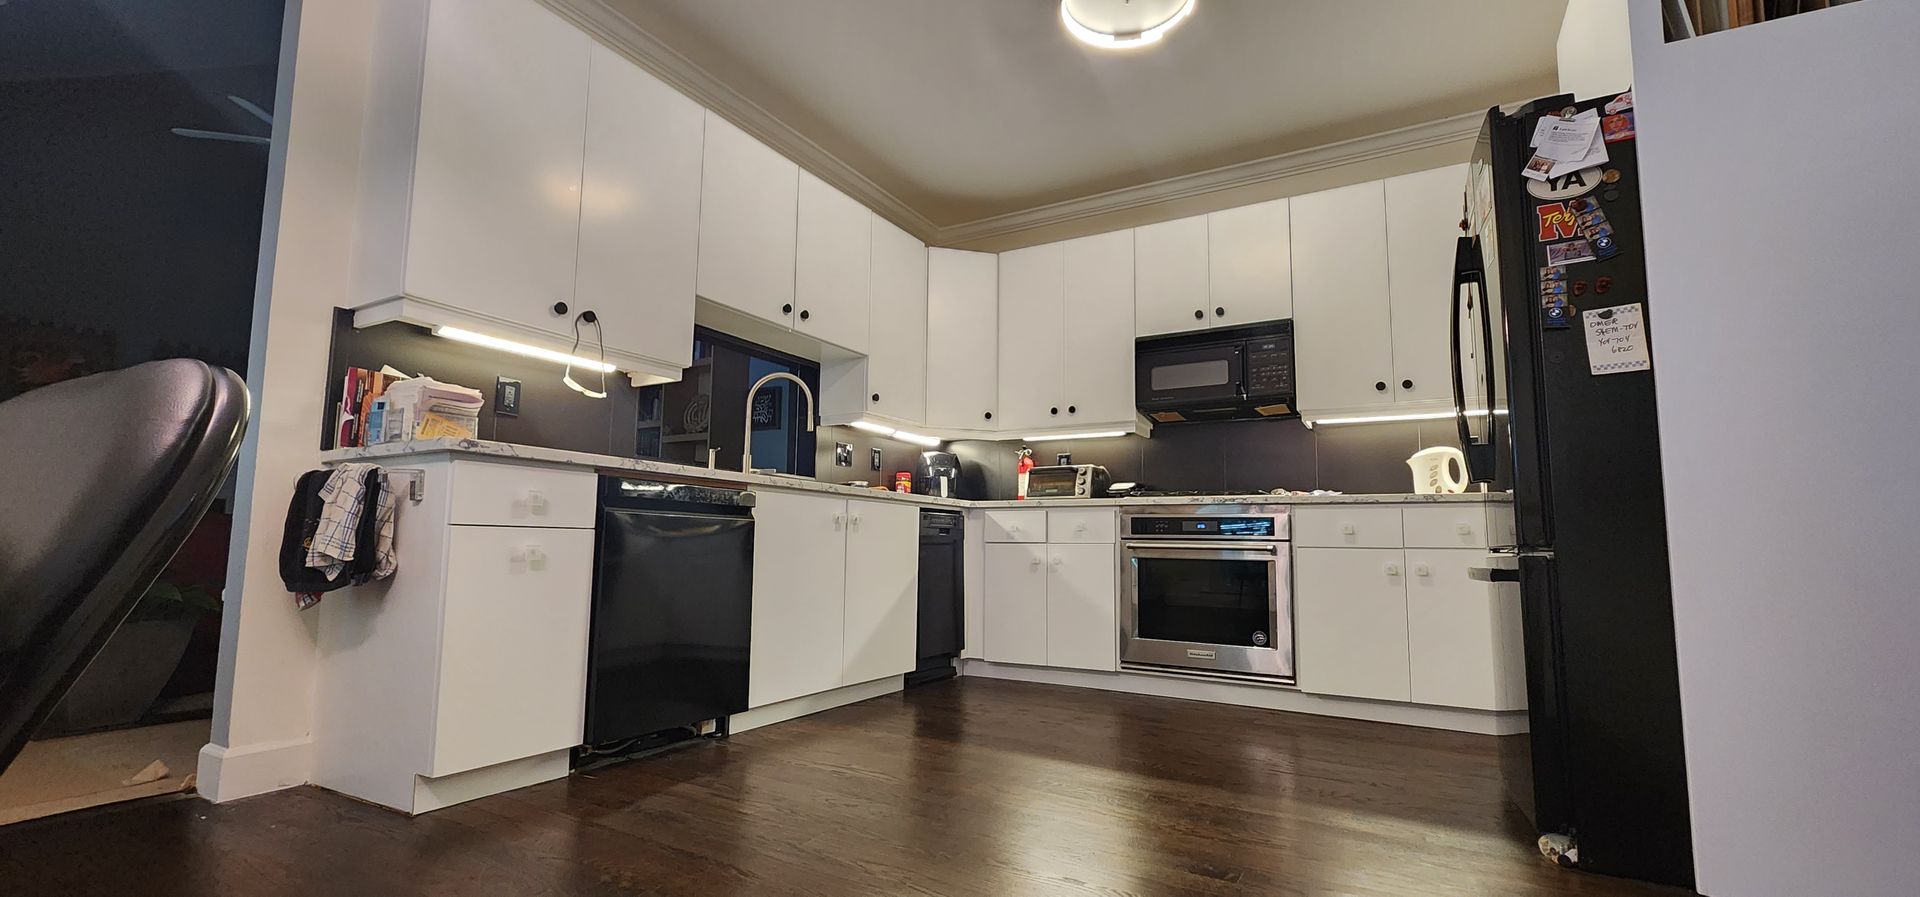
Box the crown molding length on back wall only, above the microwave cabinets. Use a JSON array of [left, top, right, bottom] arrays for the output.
[[939, 111, 1486, 246]]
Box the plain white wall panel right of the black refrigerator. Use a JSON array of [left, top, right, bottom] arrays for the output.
[[1632, 0, 1920, 897]]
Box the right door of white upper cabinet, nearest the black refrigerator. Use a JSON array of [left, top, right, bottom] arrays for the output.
[[1386, 165, 1467, 407]]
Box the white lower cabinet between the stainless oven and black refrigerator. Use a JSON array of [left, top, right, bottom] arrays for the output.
[[1292, 505, 1526, 711]]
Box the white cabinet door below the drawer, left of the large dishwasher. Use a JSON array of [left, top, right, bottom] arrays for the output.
[[430, 526, 593, 776]]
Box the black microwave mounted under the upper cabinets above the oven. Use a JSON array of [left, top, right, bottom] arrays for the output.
[[1133, 321, 1300, 424]]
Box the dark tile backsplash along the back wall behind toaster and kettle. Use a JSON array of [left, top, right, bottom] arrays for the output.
[[950, 421, 1457, 499]]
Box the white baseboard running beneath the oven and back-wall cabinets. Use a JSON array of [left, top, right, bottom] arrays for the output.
[[960, 659, 1526, 736]]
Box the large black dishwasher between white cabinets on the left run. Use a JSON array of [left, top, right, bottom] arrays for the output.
[[586, 476, 753, 753]]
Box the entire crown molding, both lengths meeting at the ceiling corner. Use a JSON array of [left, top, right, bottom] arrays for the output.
[[541, 0, 1486, 253]]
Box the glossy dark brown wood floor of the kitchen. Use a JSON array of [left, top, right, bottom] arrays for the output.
[[0, 678, 1680, 897]]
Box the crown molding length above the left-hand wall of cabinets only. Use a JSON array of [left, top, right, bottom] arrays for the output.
[[540, 0, 939, 242]]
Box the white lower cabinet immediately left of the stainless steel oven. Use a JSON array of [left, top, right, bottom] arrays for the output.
[[979, 509, 1119, 670]]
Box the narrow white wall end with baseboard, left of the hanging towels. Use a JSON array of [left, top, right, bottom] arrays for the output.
[[198, 0, 374, 801]]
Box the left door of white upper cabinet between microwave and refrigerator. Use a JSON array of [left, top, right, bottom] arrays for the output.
[[1290, 181, 1394, 413]]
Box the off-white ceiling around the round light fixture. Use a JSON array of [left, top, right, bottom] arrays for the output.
[[605, 0, 1567, 227]]
